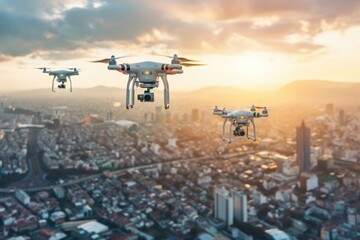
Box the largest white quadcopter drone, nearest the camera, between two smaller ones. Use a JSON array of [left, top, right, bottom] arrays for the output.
[[93, 54, 205, 109]]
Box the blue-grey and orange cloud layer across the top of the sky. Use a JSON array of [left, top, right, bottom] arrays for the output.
[[0, 0, 360, 61]]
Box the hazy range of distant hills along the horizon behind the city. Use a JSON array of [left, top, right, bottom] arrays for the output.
[[5, 80, 360, 106]]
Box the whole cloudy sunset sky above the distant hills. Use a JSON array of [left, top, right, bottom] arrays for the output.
[[0, 0, 360, 91]]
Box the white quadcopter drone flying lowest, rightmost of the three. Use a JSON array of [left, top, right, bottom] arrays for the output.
[[213, 105, 269, 143]]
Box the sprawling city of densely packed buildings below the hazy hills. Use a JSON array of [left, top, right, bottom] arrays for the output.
[[0, 91, 360, 240]]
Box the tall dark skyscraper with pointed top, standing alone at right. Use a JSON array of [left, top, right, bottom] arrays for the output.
[[296, 121, 311, 172]]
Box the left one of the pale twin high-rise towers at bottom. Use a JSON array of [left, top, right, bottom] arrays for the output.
[[215, 188, 234, 226]]
